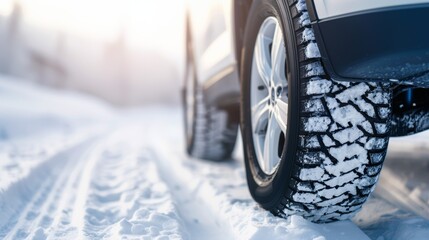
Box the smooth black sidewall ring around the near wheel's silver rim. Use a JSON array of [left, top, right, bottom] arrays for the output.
[[240, 0, 300, 210]]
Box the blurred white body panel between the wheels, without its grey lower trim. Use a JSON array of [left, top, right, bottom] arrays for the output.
[[187, 0, 236, 84]]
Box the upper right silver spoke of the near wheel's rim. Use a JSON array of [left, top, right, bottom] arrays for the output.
[[270, 24, 286, 85]]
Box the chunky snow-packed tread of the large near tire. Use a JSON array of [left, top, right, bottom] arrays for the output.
[[271, 0, 391, 222]]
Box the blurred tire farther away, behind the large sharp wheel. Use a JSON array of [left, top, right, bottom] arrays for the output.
[[182, 38, 238, 161]]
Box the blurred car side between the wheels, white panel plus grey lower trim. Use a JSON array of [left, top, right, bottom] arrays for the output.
[[187, 0, 240, 105]]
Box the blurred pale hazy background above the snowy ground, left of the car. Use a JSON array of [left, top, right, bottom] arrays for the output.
[[0, 0, 185, 107]]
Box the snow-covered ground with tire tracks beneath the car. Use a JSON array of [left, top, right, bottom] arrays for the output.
[[0, 77, 429, 240]]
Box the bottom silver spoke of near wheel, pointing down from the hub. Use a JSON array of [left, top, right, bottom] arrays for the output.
[[263, 115, 280, 171]]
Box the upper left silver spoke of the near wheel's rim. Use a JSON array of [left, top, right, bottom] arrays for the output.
[[254, 29, 271, 87]]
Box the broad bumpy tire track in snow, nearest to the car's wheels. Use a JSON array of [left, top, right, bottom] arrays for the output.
[[79, 129, 186, 239]]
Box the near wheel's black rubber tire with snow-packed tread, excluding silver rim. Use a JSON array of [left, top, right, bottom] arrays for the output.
[[242, 0, 392, 222]]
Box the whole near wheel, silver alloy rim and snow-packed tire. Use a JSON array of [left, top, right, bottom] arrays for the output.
[[241, 0, 391, 222]]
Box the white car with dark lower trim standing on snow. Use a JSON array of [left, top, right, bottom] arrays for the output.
[[182, 0, 429, 222]]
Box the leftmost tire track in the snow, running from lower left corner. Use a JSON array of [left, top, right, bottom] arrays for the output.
[[0, 136, 101, 239]]
